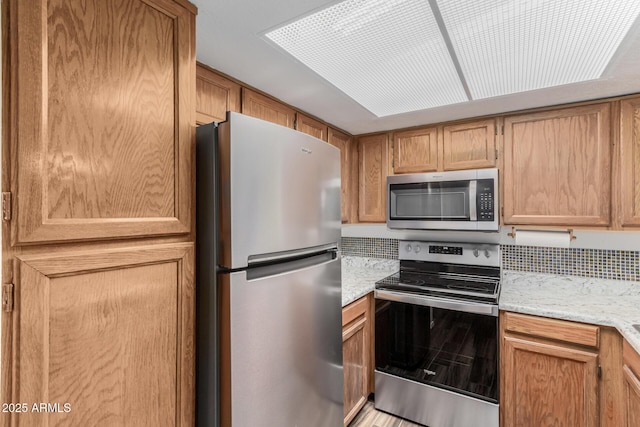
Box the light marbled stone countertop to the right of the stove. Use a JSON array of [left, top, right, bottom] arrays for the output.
[[500, 271, 640, 353]]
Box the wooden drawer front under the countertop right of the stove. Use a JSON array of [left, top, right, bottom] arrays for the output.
[[503, 312, 600, 348]]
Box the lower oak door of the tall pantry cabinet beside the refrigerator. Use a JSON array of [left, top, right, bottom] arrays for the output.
[[7, 243, 195, 427]]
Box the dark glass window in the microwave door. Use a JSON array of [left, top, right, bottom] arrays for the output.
[[390, 181, 471, 221]]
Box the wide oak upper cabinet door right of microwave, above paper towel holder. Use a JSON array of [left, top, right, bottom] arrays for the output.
[[503, 103, 611, 226]]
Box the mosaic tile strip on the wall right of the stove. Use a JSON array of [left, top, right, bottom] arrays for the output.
[[502, 245, 640, 281]]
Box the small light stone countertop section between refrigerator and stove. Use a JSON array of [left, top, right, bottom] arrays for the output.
[[342, 256, 400, 307]]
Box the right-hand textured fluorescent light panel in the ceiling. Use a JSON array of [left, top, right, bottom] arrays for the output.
[[437, 0, 640, 99]]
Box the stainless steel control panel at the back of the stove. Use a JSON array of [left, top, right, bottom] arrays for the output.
[[398, 240, 501, 267]]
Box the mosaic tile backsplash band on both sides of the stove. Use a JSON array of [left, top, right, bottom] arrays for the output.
[[342, 237, 640, 282]]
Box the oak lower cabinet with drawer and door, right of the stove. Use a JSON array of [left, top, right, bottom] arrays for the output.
[[500, 313, 600, 427]]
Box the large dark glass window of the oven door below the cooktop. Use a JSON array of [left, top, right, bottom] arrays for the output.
[[375, 300, 498, 403]]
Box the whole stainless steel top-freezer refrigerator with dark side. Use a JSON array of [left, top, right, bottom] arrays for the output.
[[196, 113, 343, 427]]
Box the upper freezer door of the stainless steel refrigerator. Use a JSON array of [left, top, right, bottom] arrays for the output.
[[218, 113, 341, 269]]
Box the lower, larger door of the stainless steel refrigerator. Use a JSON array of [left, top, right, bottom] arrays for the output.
[[219, 252, 343, 427]]
